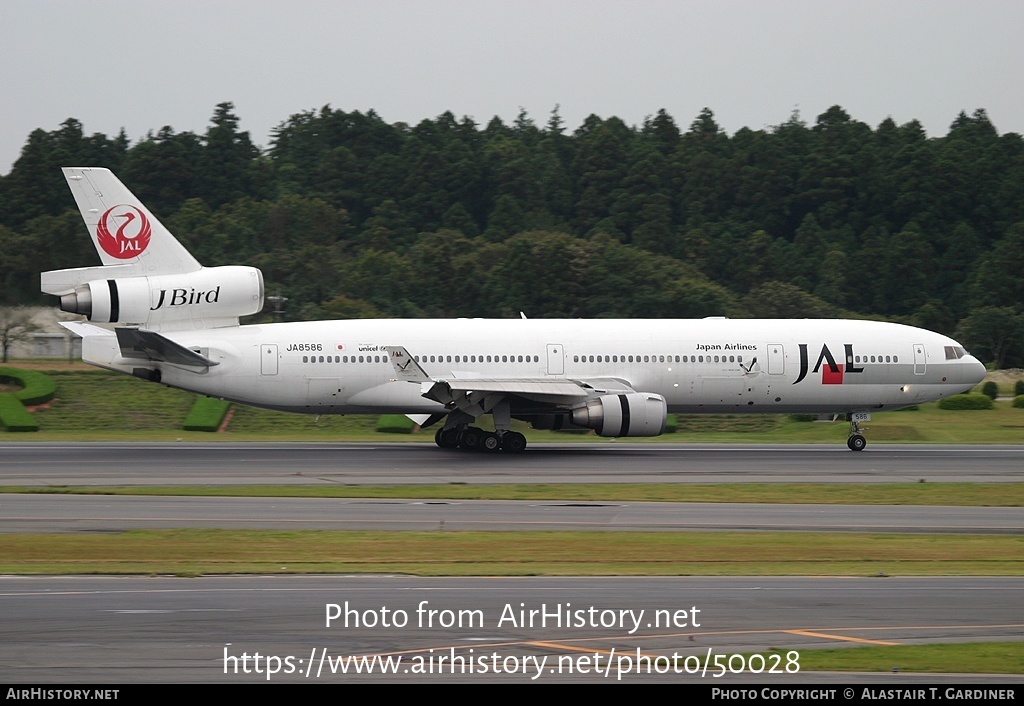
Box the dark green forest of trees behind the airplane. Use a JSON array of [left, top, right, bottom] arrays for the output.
[[0, 102, 1024, 367]]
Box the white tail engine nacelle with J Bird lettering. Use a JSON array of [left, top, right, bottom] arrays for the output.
[[60, 265, 263, 327]]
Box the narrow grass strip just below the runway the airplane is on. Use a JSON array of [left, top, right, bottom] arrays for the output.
[[0, 477, 1024, 507]]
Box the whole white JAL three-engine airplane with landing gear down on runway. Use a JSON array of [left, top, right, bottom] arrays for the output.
[[41, 167, 985, 453]]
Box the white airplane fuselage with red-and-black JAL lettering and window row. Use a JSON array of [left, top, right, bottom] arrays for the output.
[[83, 319, 985, 414]]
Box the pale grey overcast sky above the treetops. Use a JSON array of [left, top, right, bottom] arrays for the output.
[[0, 0, 1024, 174]]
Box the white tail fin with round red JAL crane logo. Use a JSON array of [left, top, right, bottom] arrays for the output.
[[62, 167, 202, 276]]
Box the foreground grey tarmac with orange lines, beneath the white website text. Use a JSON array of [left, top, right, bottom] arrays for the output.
[[0, 576, 1024, 686]]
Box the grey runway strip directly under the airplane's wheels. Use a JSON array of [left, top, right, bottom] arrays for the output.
[[0, 442, 1024, 486]]
